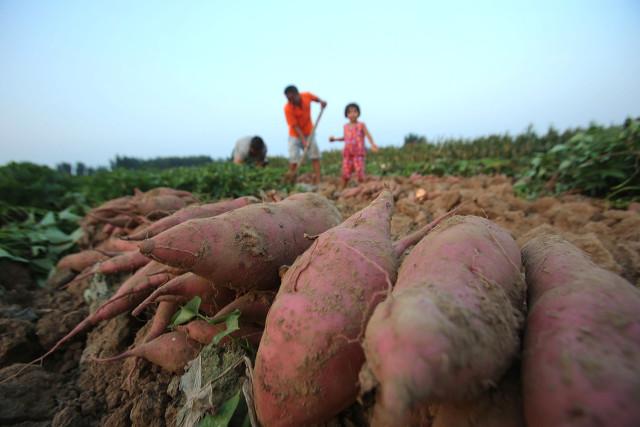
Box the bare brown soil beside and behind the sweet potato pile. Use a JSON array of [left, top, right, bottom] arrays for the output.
[[0, 176, 640, 427]]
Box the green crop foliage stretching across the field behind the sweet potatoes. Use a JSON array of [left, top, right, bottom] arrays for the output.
[[0, 119, 640, 284]]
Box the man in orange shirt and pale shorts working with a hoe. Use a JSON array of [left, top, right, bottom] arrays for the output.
[[284, 85, 327, 184]]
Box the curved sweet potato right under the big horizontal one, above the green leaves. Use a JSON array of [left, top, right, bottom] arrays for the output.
[[132, 273, 236, 316]]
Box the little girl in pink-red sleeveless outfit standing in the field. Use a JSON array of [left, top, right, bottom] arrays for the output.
[[329, 102, 378, 188]]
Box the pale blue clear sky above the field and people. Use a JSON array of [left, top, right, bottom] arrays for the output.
[[0, 0, 640, 166]]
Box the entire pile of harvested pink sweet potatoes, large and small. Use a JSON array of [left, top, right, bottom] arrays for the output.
[[40, 190, 640, 427]]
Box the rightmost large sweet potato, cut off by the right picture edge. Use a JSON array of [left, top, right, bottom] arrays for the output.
[[523, 234, 640, 427]]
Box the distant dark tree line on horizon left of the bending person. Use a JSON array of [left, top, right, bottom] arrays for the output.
[[56, 156, 213, 176]]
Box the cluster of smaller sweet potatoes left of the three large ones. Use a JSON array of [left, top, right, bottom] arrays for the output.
[[42, 189, 342, 372]]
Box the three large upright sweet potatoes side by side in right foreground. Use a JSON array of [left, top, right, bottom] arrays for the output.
[[253, 195, 640, 427]]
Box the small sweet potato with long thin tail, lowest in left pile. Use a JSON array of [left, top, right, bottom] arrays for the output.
[[94, 331, 201, 374]]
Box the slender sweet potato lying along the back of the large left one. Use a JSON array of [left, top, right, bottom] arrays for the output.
[[125, 196, 259, 240]]
